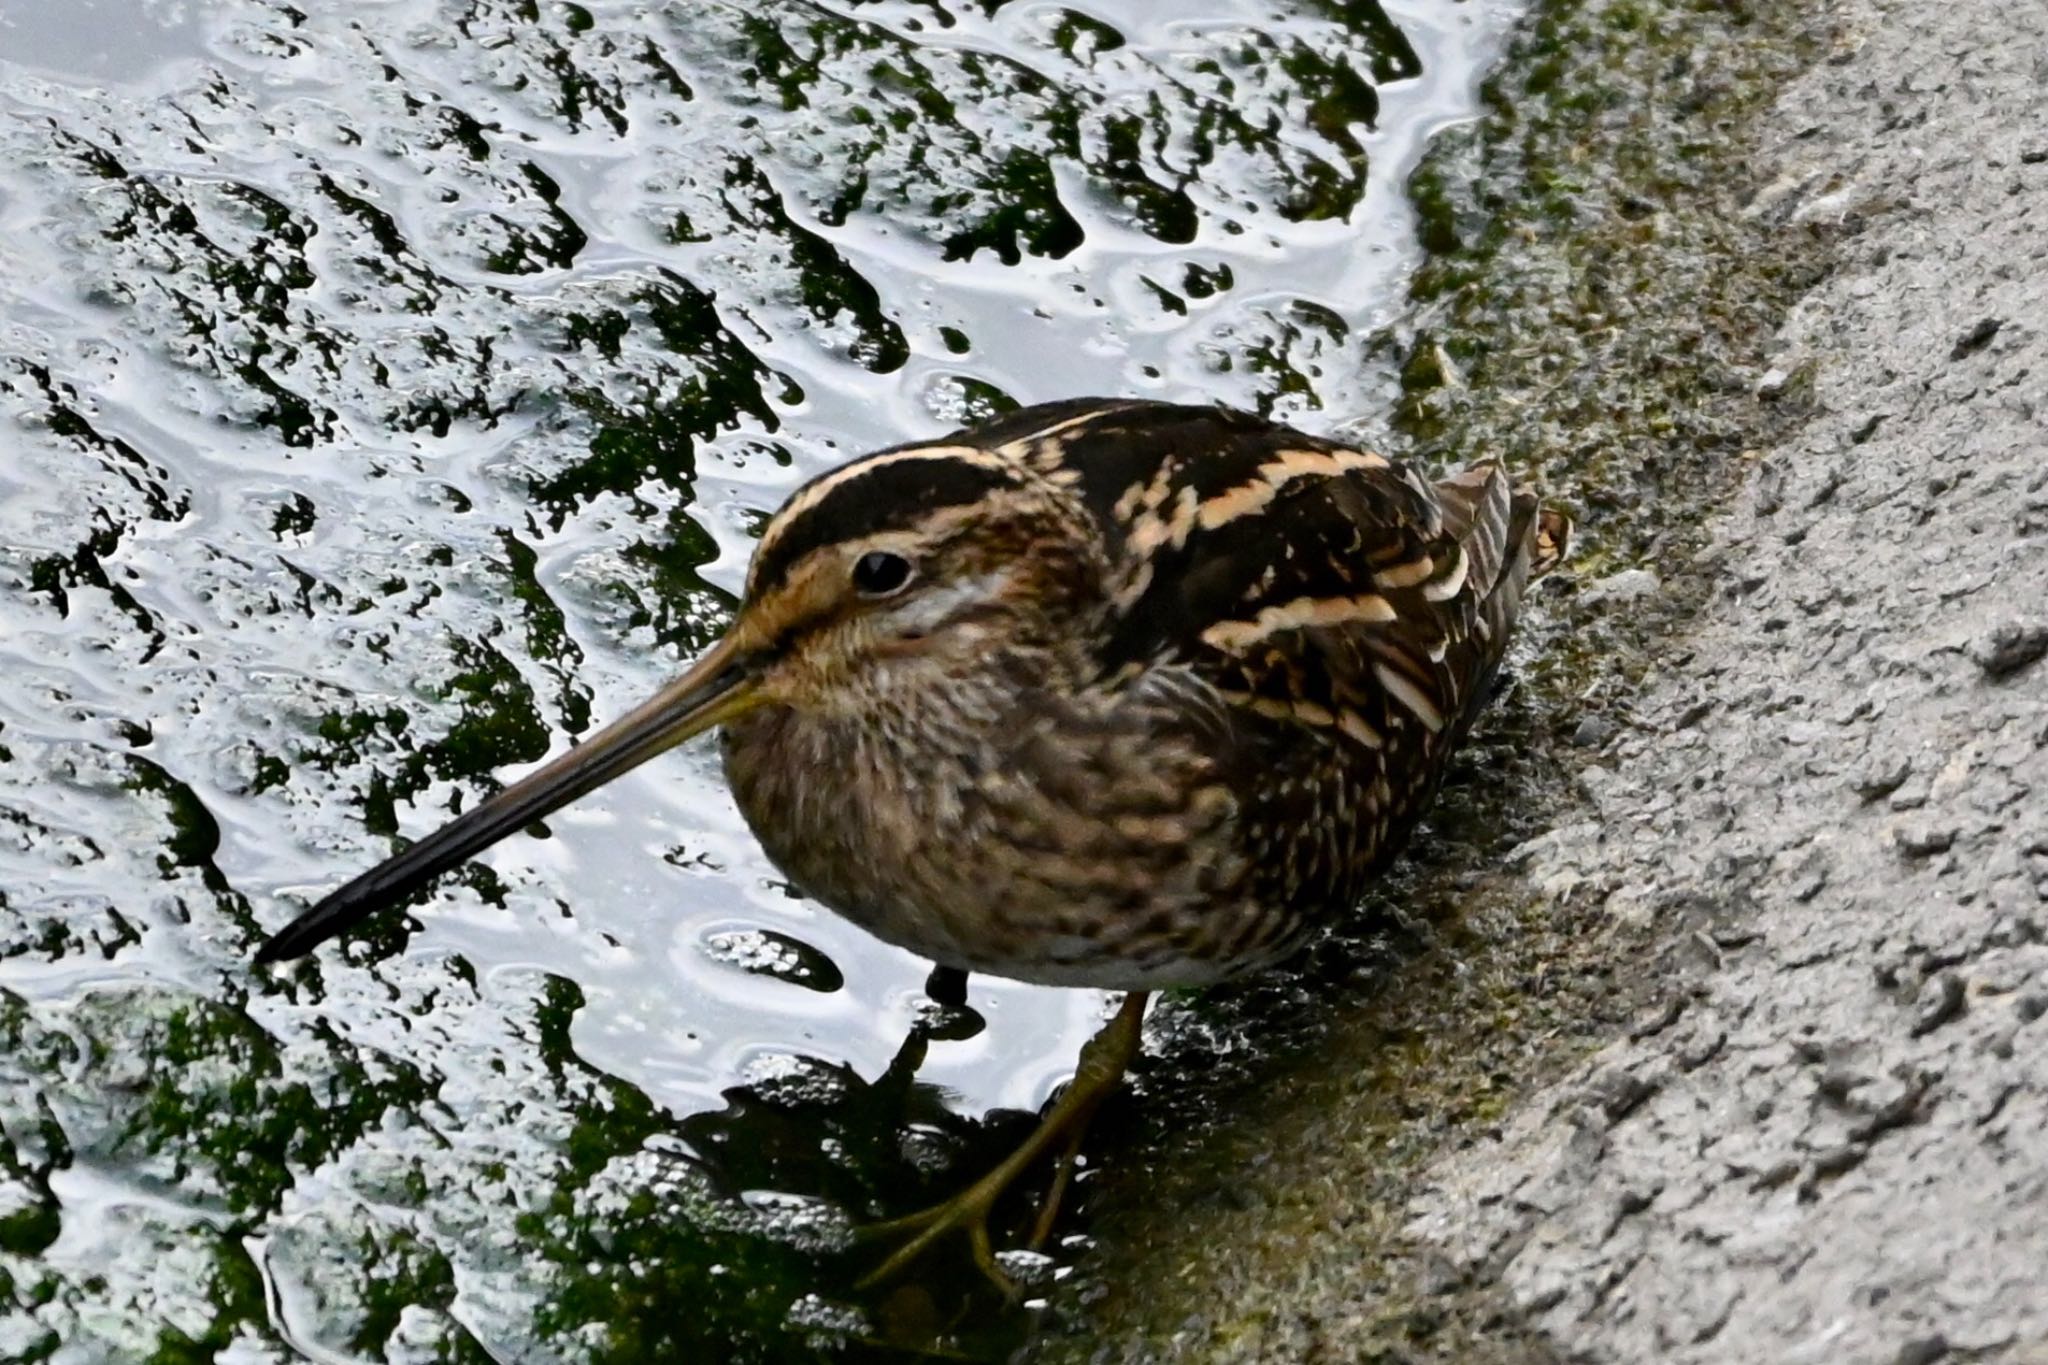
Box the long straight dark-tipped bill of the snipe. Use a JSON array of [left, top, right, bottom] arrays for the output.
[[256, 636, 756, 964]]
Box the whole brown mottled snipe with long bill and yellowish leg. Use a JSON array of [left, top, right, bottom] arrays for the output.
[[258, 399, 1567, 1275]]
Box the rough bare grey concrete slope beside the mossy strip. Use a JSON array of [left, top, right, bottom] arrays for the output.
[[1409, 0, 2048, 1365]]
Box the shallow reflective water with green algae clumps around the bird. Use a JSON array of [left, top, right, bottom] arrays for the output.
[[0, 0, 1511, 1361]]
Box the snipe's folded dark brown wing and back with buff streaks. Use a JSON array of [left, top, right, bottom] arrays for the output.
[[950, 399, 1561, 761]]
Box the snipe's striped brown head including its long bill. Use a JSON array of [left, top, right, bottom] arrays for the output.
[[256, 446, 1102, 962]]
